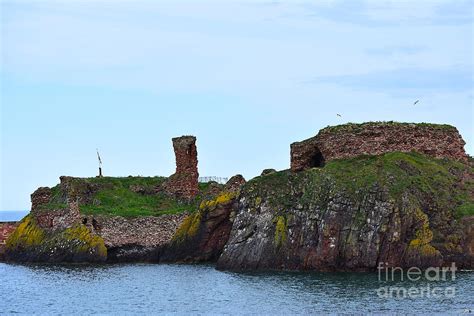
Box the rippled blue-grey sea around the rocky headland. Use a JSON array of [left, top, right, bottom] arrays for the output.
[[0, 212, 474, 315]]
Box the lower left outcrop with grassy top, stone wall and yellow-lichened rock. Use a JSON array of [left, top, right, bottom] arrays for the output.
[[5, 177, 218, 262]]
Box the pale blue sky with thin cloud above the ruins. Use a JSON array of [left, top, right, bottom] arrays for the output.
[[0, 0, 474, 210]]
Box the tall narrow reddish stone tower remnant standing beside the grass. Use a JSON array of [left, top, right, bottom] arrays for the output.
[[166, 136, 199, 200]]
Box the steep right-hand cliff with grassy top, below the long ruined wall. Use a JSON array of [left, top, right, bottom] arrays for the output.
[[218, 153, 474, 271]]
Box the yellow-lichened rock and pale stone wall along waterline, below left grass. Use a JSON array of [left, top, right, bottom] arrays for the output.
[[5, 210, 187, 262]]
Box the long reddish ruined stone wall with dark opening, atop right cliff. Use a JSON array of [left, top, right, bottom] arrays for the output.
[[291, 122, 467, 171]]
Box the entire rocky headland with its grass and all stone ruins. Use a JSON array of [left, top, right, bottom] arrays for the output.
[[5, 123, 474, 271]]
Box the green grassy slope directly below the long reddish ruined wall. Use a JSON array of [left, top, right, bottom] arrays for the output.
[[244, 152, 474, 218]]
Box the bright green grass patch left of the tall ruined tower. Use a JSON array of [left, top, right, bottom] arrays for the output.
[[43, 177, 215, 217]]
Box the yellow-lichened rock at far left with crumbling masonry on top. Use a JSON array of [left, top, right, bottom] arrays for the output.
[[4, 187, 107, 262]]
